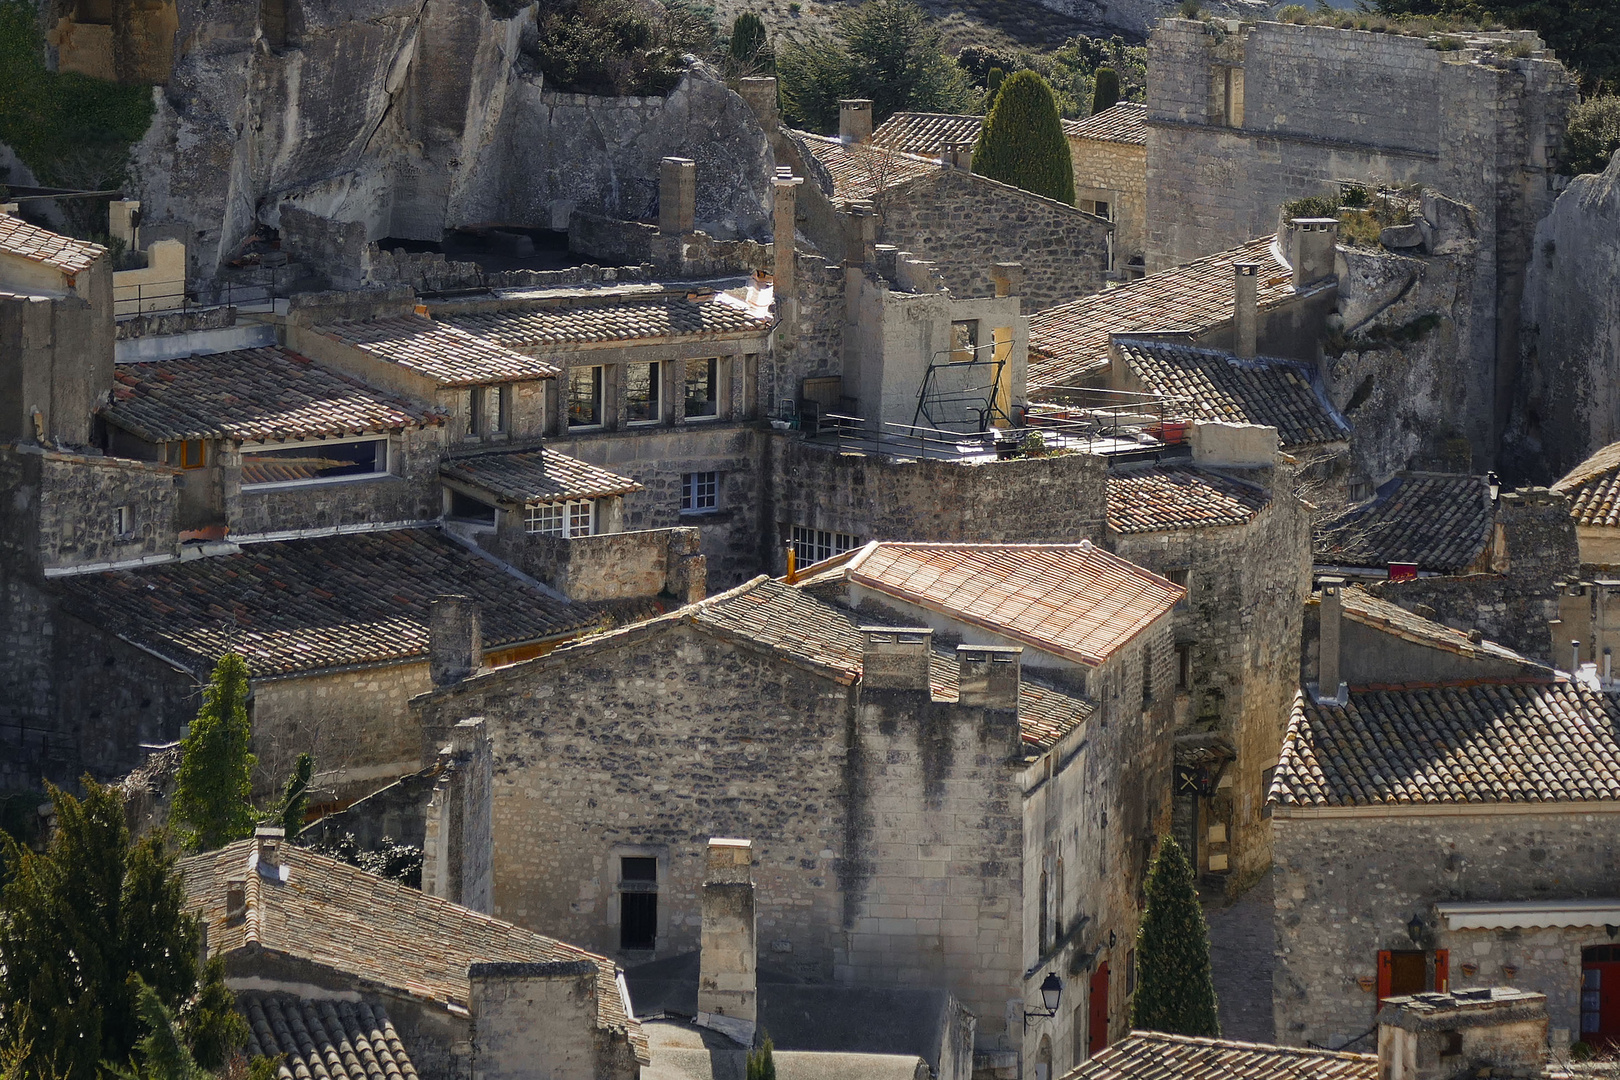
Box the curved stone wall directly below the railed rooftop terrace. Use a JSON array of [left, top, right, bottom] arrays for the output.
[[765, 434, 1106, 572]]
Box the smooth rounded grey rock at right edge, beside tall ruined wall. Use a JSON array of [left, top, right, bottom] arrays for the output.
[[1503, 154, 1620, 483]]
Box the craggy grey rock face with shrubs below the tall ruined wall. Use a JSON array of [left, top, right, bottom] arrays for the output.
[[1324, 193, 1479, 484]]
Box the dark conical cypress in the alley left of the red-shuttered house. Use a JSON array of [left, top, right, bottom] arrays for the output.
[[1131, 836, 1220, 1038]]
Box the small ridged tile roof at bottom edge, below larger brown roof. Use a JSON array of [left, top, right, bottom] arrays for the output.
[[237, 991, 416, 1080]]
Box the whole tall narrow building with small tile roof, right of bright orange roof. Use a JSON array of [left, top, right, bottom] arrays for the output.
[[1105, 423, 1311, 895]]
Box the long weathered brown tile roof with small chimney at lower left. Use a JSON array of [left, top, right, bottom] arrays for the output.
[[180, 840, 648, 1062]]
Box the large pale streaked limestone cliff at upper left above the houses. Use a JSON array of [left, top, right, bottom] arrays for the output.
[[131, 0, 771, 280]]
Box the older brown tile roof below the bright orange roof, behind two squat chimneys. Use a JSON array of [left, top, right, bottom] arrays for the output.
[[690, 578, 1095, 751]]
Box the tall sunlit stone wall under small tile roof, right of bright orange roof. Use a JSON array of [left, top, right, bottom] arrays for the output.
[[1110, 470, 1311, 894]]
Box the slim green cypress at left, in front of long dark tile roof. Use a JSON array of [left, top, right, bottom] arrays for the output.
[[173, 653, 258, 852]]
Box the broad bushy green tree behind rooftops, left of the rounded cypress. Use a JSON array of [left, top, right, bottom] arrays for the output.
[[776, 0, 978, 133]]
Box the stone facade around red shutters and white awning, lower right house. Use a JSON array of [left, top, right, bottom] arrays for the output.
[[1273, 803, 1620, 1049]]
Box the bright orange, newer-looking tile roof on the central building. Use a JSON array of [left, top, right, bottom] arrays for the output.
[[842, 542, 1186, 665]]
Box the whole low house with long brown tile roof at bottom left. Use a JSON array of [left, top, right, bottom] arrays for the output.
[[180, 827, 650, 1080]]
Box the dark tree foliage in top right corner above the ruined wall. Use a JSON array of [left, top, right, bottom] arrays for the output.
[[1374, 0, 1620, 94]]
